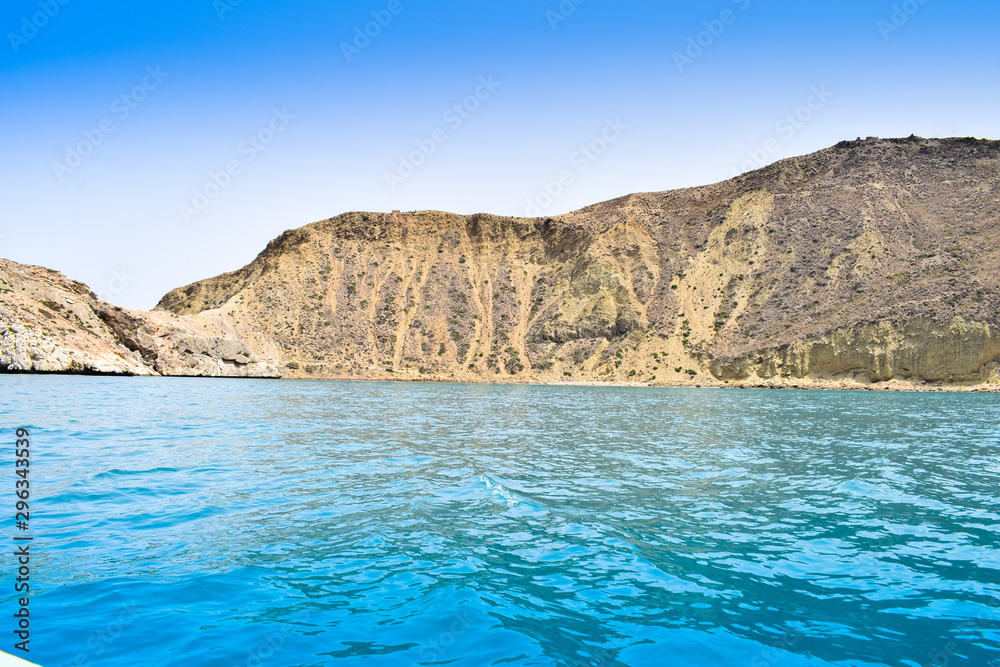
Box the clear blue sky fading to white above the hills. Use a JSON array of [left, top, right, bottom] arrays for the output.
[[0, 0, 1000, 308]]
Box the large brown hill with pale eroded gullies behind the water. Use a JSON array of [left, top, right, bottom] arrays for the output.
[[156, 137, 1000, 385]]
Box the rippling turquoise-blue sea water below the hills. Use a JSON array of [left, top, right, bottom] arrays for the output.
[[0, 376, 1000, 667]]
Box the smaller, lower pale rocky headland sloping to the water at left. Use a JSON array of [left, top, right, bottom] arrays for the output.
[[0, 260, 278, 377]]
